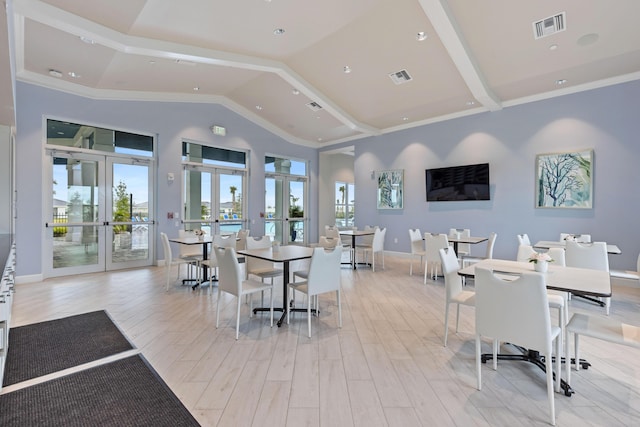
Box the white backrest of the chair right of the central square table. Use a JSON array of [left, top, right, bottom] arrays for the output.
[[307, 246, 342, 295]]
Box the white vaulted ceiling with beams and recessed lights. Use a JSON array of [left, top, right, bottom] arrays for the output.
[[0, 0, 640, 147]]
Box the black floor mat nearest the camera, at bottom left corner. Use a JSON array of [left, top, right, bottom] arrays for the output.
[[0, 355, 199, 427]]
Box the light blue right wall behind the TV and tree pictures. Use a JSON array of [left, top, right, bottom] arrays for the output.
[[332, 81, 640, 269]]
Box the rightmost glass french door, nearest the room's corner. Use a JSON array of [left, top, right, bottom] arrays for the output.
[[264, 174, 308, 245]]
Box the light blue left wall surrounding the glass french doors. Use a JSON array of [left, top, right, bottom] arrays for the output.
[[16, 83, 318, 276]]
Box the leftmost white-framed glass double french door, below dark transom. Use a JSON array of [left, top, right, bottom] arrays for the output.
[[43, 150, 155, 277]]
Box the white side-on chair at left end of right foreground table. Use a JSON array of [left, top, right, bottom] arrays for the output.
[[438, 247, 475, 347]]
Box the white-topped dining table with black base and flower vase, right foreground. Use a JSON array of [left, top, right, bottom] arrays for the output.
[[458, 259, 611, 396]]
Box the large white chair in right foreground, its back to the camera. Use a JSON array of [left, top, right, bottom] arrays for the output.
[[475, 267, 562, 425]]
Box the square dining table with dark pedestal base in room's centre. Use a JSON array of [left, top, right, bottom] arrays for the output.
[[237, 245, 317, 327]]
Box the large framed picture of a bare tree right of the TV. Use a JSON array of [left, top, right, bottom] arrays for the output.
[[534, 149, 594, 209]]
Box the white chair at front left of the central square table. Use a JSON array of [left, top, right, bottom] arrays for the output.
[[214, 247, 273, 340]]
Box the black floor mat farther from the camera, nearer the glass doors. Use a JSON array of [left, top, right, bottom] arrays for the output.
[[2, 311, 133, 386]]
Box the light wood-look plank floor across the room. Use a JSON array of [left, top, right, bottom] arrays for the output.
[[6, 256, 640, 427]]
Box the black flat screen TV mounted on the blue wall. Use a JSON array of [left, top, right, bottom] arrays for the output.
[[425, 163, 489, 202]]
